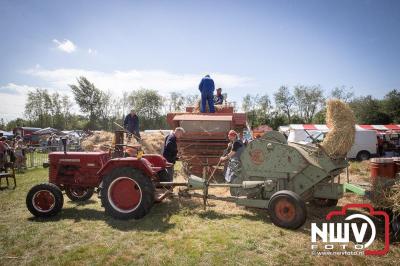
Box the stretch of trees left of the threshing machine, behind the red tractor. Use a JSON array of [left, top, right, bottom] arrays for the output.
[[0, 77, 199, 131]]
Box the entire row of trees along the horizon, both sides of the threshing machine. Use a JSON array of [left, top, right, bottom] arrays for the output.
[[0, 77, 400, 131]]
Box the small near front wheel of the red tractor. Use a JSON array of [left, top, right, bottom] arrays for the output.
[[26, 183, 64, 217]]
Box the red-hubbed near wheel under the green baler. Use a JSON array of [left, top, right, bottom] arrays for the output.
[[268, 190, 307, 229]]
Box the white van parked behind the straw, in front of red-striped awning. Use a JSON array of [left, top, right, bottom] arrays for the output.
[[288, 125, 377, 161]]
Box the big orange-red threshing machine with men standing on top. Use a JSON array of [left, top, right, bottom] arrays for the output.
[[167, 104, 246, 176]]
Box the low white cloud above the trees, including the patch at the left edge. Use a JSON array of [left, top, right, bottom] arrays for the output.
[[0, 65, 253, 120]]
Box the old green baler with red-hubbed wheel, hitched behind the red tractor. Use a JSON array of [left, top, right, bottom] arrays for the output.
[[181, 131, 348, 229]]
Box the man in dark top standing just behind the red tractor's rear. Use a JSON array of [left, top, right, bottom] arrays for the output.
[[163, 127, 185, 182]]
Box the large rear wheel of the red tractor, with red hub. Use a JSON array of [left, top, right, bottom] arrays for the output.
[[100, 167, 154, 219]]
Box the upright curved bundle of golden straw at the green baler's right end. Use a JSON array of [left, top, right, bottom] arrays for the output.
[[321, 99, 356, 159]]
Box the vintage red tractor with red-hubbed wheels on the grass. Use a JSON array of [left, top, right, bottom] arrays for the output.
[[26, 133, 172, 219]]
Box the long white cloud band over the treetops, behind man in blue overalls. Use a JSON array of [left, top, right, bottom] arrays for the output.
[[27, 68, 253, 94]]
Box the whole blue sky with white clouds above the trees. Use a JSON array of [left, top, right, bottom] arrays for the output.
[[0, 0, 400, 120]]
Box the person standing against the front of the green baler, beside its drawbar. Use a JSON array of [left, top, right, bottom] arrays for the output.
[[220, 130, 244, 182]]
